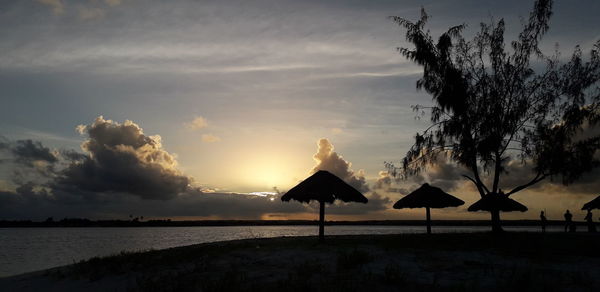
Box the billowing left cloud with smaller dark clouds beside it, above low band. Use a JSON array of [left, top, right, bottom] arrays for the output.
[[0, 117, 191, 200]]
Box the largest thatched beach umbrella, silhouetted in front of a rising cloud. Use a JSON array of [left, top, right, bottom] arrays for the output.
[[281, 170, 368, 240]]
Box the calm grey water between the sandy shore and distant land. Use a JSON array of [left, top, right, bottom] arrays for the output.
[[0, 226, 561, 277]]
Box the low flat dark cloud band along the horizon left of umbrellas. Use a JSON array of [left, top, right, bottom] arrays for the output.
[[0, 186, 313, 220]]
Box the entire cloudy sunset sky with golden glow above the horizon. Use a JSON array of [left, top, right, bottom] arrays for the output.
[[0, 0, 600, 220]]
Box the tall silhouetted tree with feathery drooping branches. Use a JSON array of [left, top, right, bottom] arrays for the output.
[[386, 0, 600, 231]]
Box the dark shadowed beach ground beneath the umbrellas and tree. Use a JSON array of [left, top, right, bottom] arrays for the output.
[[0, 233, 600, 292]]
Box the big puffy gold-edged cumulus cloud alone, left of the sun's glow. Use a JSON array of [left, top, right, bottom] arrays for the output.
[[54, 116, 191, 200]]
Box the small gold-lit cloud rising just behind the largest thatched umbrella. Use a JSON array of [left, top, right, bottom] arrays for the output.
[[312, 138, 369, 192]]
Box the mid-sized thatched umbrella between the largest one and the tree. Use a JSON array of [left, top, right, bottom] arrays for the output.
[[394, 183, 465, 233]]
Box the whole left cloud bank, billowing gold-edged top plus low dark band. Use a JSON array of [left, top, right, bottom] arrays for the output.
[[0, 116, 313, 220]]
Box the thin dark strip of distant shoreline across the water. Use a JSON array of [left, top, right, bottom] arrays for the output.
[[0, 218, 585, 228]]
